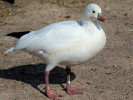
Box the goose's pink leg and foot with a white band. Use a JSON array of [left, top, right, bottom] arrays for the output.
[[66, 68, 83, 95]]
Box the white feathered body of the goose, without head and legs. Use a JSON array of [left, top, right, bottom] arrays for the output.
[[6, 21, 106, 70]]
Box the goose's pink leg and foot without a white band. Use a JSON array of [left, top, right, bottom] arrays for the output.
[[45, 71, 59, 99]]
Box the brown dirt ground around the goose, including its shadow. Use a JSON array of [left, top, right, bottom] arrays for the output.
[[0, 0, 133, 100]]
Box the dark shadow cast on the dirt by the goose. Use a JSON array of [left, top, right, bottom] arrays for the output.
[[0, 64, 76, 94]]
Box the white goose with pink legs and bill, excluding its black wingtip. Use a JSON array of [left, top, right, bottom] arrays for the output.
[[5, 3, 106, 99]]
